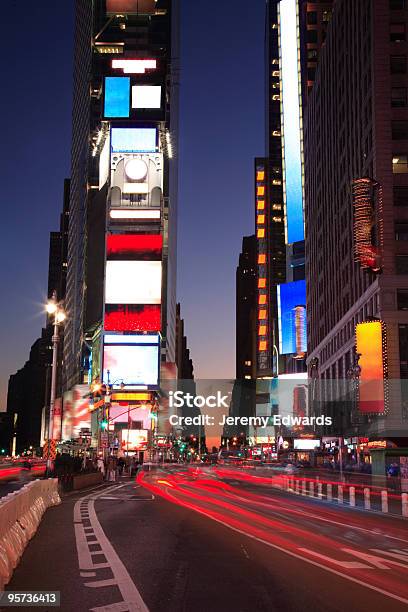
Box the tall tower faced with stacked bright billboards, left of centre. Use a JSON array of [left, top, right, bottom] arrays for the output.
[[64, 0, 179, 396]]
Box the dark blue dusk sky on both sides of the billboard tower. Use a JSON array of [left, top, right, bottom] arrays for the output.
[[0, 0, 265, 410]]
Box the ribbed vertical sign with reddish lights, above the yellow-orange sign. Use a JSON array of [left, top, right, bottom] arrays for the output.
[[353, 178, 382, 272]]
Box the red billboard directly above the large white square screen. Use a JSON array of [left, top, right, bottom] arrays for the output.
[[106, 234, 163, 261]]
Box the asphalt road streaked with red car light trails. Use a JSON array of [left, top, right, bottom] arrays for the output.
[[4, 467, 408, 612]]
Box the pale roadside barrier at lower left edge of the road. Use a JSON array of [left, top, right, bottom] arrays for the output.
[[0, 478, 61, 591]]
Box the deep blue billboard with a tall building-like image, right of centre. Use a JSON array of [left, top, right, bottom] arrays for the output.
[[277, 280, 307, 358]]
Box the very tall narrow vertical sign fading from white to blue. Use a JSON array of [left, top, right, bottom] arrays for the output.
[[278, 0, 305, 244]]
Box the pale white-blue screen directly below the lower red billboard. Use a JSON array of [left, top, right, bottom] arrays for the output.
[[103, 343, 160, 388]]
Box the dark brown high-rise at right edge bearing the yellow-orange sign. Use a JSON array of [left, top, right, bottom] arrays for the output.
[[305, 0, 408, 436]]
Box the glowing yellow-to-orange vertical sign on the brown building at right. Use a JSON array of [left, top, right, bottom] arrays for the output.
[[356, 321, 388, 414]]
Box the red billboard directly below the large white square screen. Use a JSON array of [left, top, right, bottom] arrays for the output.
[[104, 304, 161, 332]]
